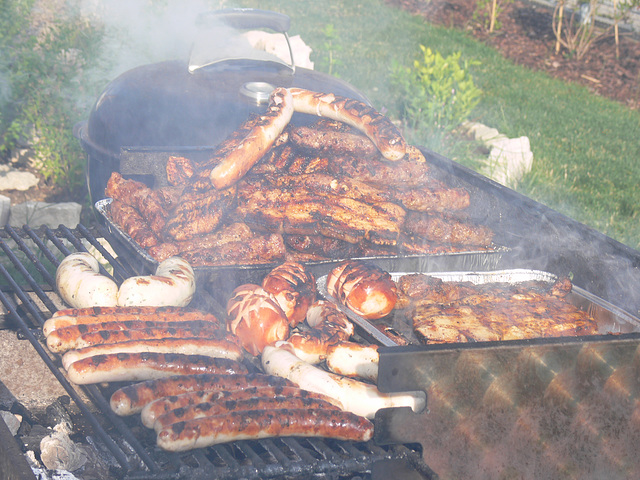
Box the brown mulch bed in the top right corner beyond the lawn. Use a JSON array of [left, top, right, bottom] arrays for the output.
[[386, 0, 640, 109]]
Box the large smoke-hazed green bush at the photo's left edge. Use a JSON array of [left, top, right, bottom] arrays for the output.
[[0, 0, 100, 189]]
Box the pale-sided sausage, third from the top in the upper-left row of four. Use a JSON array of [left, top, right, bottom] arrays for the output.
[[62, 337, 242, 370]]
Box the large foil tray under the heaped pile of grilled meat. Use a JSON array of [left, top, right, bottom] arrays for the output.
[[95, 198, 509, 302]]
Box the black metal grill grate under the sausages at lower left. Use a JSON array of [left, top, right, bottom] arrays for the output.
[[0, 225, 429, 480]]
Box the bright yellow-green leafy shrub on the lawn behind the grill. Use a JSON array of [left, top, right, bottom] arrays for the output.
[[391, 45, 482, 132]]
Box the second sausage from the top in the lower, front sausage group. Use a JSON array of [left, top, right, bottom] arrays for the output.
[[140, 384, 342, 428]]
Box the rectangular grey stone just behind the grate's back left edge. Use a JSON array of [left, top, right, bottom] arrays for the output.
[[9, 201, 82, 228]]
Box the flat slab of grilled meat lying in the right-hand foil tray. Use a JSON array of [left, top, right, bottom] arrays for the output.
[[398, 275, 598, 343]]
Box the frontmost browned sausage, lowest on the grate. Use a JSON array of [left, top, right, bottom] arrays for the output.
[[158, 409, 373, 451]]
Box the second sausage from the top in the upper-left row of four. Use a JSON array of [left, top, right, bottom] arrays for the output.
[[47, 322, 228, 353]]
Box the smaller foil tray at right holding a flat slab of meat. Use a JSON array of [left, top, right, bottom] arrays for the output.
[[317, 269, 640, 347]]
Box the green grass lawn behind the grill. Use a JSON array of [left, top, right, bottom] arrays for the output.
[[234, 0, 640, 249]]
